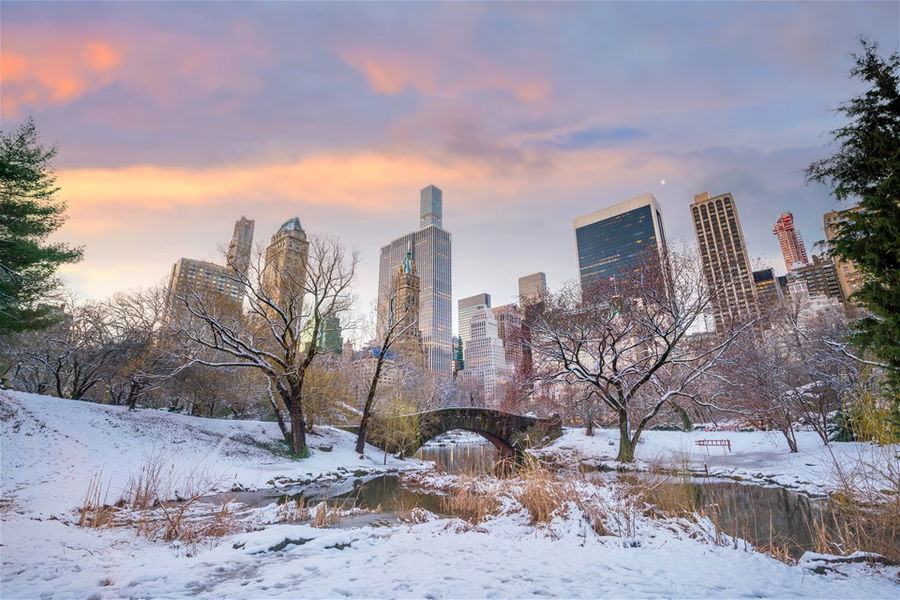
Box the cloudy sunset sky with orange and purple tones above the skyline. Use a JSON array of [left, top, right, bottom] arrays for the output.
[[0, 0, 900, 330]]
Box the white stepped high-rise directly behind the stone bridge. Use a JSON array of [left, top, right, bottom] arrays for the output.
[[463, 306, 510, 407]]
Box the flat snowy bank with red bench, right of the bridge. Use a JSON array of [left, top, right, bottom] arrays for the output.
[[539, 429, 900, 496]]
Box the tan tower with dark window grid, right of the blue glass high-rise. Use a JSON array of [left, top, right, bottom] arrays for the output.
[[691, 192, 757, 331]]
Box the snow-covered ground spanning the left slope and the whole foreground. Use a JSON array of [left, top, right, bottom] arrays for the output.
[[0, 392, 900, 600]]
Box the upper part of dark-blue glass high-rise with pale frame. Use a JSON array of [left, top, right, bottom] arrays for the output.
[[574, 194, 666, 289]]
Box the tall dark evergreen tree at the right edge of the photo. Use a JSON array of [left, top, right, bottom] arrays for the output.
[[806, 39, 900, 402]]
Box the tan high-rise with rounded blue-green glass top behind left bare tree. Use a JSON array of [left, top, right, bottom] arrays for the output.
[[260, 217, 309, 316]]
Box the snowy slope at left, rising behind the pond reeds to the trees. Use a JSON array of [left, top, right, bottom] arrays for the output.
[[0, 391, 425, 517]]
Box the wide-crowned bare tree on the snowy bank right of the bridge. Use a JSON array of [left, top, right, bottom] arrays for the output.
[[532, 254, 754, 461]]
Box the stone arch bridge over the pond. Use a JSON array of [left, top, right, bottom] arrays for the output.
[[354, 407, 562, 457]]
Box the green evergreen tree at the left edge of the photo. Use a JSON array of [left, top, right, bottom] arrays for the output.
[[0, 119, 81, 335]]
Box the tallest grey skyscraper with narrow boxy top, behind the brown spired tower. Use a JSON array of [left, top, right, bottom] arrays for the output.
[[377, 185, 453, 376]]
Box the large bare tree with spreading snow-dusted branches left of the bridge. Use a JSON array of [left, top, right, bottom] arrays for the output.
[[176, 237, 359, 455]]
